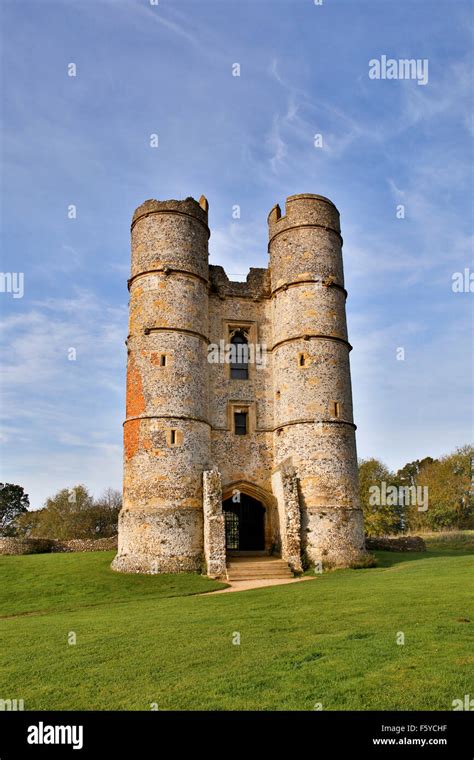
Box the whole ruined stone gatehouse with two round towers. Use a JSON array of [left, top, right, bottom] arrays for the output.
[[112, 195, 365, 576]]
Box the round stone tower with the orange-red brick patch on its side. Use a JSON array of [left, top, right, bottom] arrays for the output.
[[112, 196, 210, 573]]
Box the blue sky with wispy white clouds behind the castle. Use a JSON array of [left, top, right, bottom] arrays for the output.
[[0, 0, 473, 507]]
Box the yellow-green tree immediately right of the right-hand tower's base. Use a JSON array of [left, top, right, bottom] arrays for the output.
[[359, 459, 403, 536]]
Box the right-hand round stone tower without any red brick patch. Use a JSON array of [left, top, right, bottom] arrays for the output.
[[268, 194, 365, 566]]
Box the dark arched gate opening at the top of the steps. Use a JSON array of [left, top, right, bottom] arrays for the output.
[[222, 493, 265, 551]]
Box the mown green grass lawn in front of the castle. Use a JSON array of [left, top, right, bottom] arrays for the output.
[[0, 534, 474, 710]]
